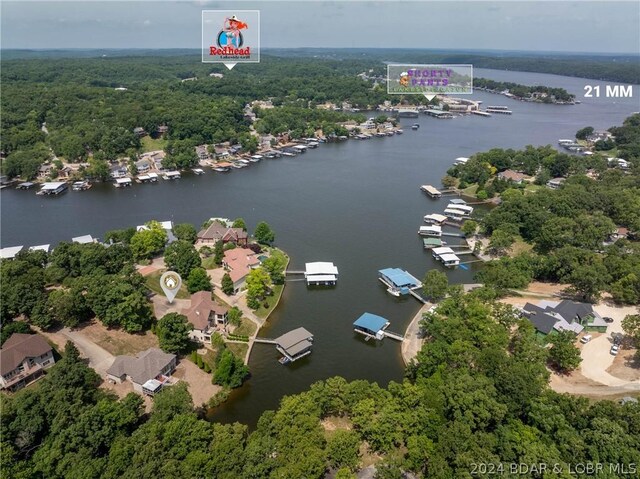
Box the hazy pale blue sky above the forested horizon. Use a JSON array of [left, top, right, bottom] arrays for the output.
[[1, 0, 640, 53]]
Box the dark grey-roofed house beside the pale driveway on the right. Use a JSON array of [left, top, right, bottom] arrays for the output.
[[522, 300, 608, 337]]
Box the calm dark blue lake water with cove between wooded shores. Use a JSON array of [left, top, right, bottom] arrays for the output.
[[0, 69, 640, 426]]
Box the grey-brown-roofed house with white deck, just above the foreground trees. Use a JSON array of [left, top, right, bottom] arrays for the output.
[[107, 348, 178, 396]]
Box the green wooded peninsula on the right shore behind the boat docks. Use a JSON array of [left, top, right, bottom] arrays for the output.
[[445, 114, 640, 304]]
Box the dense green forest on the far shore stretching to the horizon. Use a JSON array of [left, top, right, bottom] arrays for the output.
[[0, 50, 640, 180]]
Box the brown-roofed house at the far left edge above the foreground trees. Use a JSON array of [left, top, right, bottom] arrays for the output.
[[0, 333, 56, 391]]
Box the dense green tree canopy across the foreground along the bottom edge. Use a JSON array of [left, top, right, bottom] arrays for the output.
[[0, 288, 640, 479]]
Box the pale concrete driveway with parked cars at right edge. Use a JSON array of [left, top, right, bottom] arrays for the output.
[[580, 303, 640, 391]]
